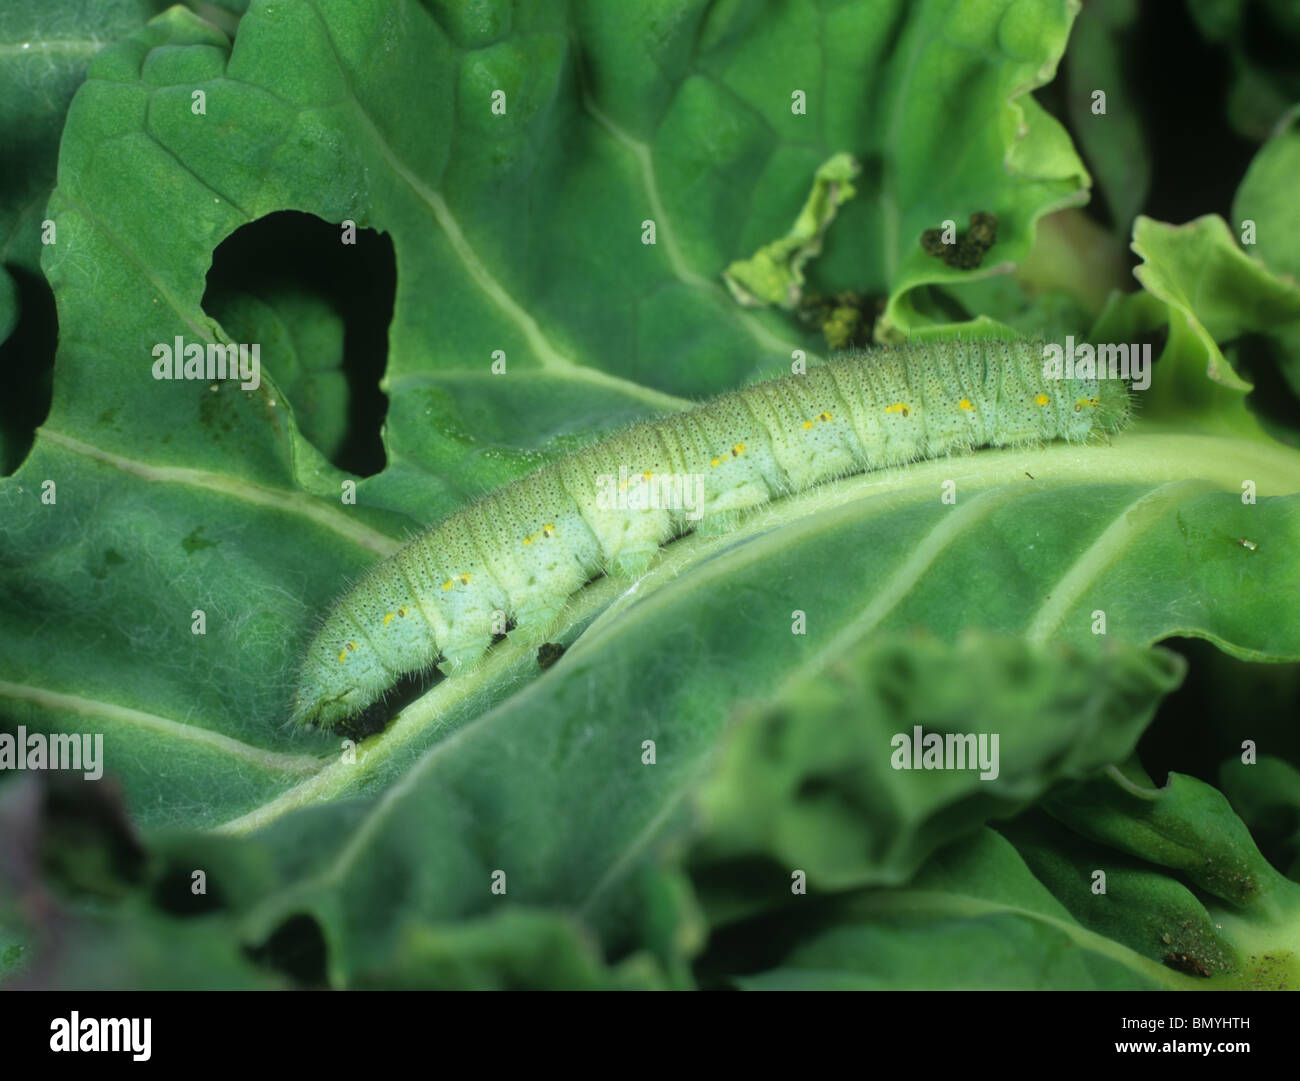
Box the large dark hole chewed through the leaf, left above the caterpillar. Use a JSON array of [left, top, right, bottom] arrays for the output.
[[203, 210, 397, 477]]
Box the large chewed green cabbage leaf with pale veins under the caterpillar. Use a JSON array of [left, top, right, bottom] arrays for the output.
[[0, 0, 1300, 986]]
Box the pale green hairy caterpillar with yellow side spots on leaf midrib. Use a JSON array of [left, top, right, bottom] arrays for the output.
[[293, 340, 1131, 728]]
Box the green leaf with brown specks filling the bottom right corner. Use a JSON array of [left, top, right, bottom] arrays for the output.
[[736, 767, 1300, 990]]
